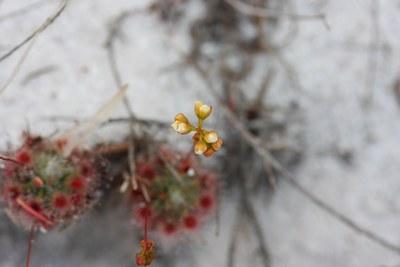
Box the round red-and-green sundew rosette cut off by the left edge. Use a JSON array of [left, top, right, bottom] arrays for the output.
[[0, 135, 99, 230]]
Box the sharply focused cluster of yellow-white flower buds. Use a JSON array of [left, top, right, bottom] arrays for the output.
[[171, 101, 222, 157]]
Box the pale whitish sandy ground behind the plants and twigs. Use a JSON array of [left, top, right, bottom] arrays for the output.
[[0, 0, 400, 267]]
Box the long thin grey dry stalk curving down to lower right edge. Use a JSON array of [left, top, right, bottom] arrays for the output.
[[186, 56, 400, 255]]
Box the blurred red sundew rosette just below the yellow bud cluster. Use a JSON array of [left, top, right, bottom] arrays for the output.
[[132, 149, 217, 237]]
